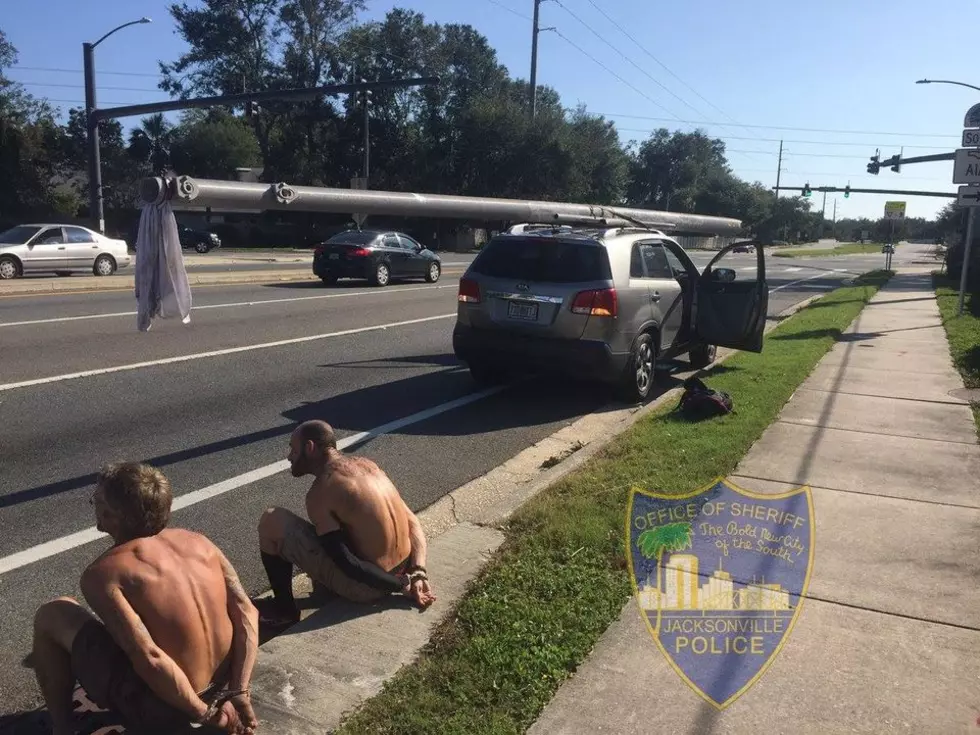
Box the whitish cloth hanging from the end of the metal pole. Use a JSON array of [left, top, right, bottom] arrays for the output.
[[136, 192, 191, 332]]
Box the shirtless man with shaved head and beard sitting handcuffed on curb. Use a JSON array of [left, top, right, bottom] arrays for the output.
[[257, 421, 436, 628]]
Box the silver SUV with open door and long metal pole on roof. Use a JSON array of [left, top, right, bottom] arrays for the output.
[[453, 225, 769, 403]]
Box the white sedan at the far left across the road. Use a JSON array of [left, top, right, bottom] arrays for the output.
[[0, 224, 133, 279]]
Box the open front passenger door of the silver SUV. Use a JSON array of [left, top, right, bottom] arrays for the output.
[[695, 241, 769, 352]]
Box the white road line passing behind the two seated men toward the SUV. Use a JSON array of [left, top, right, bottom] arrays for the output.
[[0, 386, 507, 575]]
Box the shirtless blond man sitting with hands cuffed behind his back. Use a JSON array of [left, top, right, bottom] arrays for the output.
[[32, 463, 258, 735]]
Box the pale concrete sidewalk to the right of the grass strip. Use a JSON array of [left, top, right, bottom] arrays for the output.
[[530, 268, 980, 735]]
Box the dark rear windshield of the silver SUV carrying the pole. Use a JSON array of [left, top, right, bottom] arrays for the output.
[[472, 237, 612, 283]]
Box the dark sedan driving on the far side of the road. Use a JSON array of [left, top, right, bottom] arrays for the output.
[[313, 230, 442, 286]]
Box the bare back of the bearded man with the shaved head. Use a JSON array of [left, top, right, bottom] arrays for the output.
[[306, 452, 412, 570]]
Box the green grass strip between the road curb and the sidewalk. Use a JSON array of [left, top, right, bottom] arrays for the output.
[[339, 272, 890, 735]]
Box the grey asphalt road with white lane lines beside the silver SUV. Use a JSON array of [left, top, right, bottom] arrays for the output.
[[0, 244, 909, 715]]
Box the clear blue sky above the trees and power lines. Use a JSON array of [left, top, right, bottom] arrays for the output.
[[0, 0, 980, 218]]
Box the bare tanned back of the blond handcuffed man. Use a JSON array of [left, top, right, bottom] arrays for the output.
[[82, 529, 233, 692]]
